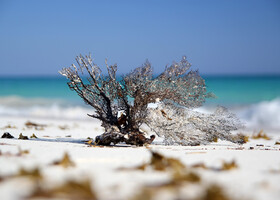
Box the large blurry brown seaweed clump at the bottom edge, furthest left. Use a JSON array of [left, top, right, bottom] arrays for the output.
[[28, 180, 97, 200]]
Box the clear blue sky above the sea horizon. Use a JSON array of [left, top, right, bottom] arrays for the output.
[[0, 0, 280, 76]]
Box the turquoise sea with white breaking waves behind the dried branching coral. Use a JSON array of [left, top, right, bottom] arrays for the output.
[[0, 76, 280, 130]]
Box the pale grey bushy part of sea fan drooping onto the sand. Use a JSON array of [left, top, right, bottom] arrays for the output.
[[146, 103, 246, 145]]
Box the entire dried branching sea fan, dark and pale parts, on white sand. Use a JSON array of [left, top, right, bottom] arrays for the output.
[[59, 55, 246, 146]]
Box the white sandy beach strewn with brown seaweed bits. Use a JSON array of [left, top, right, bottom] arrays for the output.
[[0, 117, 280, 200]]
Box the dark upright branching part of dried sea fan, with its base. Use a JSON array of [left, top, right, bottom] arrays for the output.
[[60, 55, 211, 145]]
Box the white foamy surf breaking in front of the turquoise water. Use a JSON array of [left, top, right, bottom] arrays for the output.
[[0, 96, 280, 130]]
